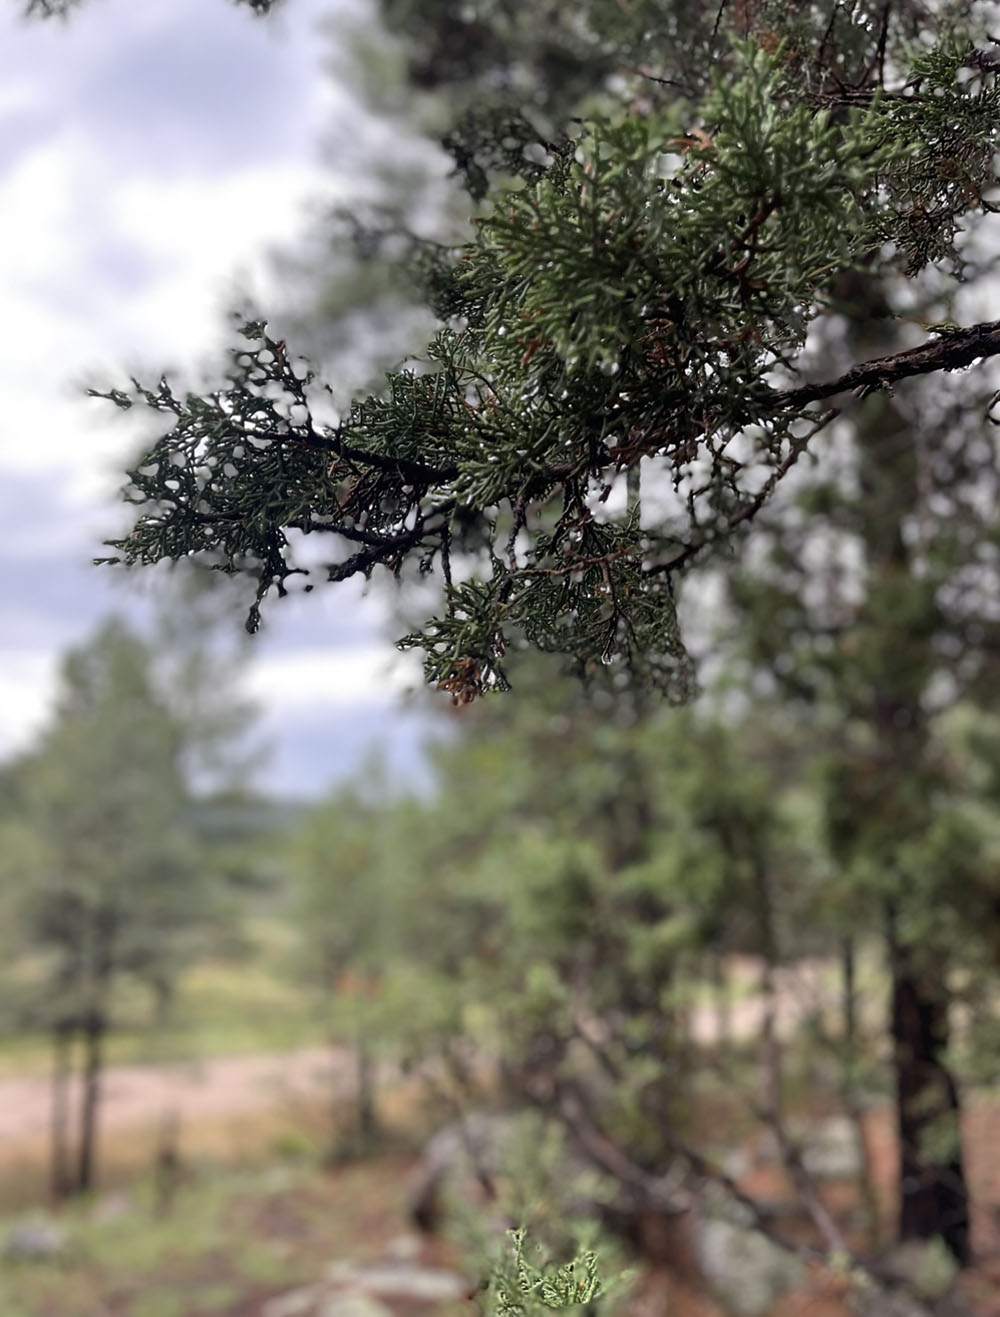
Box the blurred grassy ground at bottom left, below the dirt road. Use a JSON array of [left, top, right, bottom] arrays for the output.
[[0, 1156, 418, 1317]]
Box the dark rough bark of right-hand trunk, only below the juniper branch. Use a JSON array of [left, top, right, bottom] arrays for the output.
[[863, 399, 970, 1264]]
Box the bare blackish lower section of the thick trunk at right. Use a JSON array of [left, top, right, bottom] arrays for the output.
[[887, 910, 971, 1266]]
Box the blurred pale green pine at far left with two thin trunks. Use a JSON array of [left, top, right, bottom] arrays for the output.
[[11, 622, 204, 1197]]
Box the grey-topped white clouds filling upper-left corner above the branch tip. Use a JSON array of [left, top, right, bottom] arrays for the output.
[[0, 0, 348, 479]]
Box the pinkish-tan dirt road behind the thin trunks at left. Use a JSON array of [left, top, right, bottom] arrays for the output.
[[0, 1047, 353, 1156]]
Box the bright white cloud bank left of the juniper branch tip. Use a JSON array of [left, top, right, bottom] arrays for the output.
[[0, 134, 332, 474]]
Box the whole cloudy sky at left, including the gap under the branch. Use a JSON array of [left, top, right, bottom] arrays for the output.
[[0, 0, 442, 795]]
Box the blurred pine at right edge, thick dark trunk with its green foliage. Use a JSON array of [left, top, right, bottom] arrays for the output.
[[730, 267, 999, 1262]]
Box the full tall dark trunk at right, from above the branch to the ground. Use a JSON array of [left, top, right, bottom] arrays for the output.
[[852, 281, 970, 1264]]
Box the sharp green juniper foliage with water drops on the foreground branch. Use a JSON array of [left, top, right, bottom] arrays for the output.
[[92, 0, 1000, 702]]
